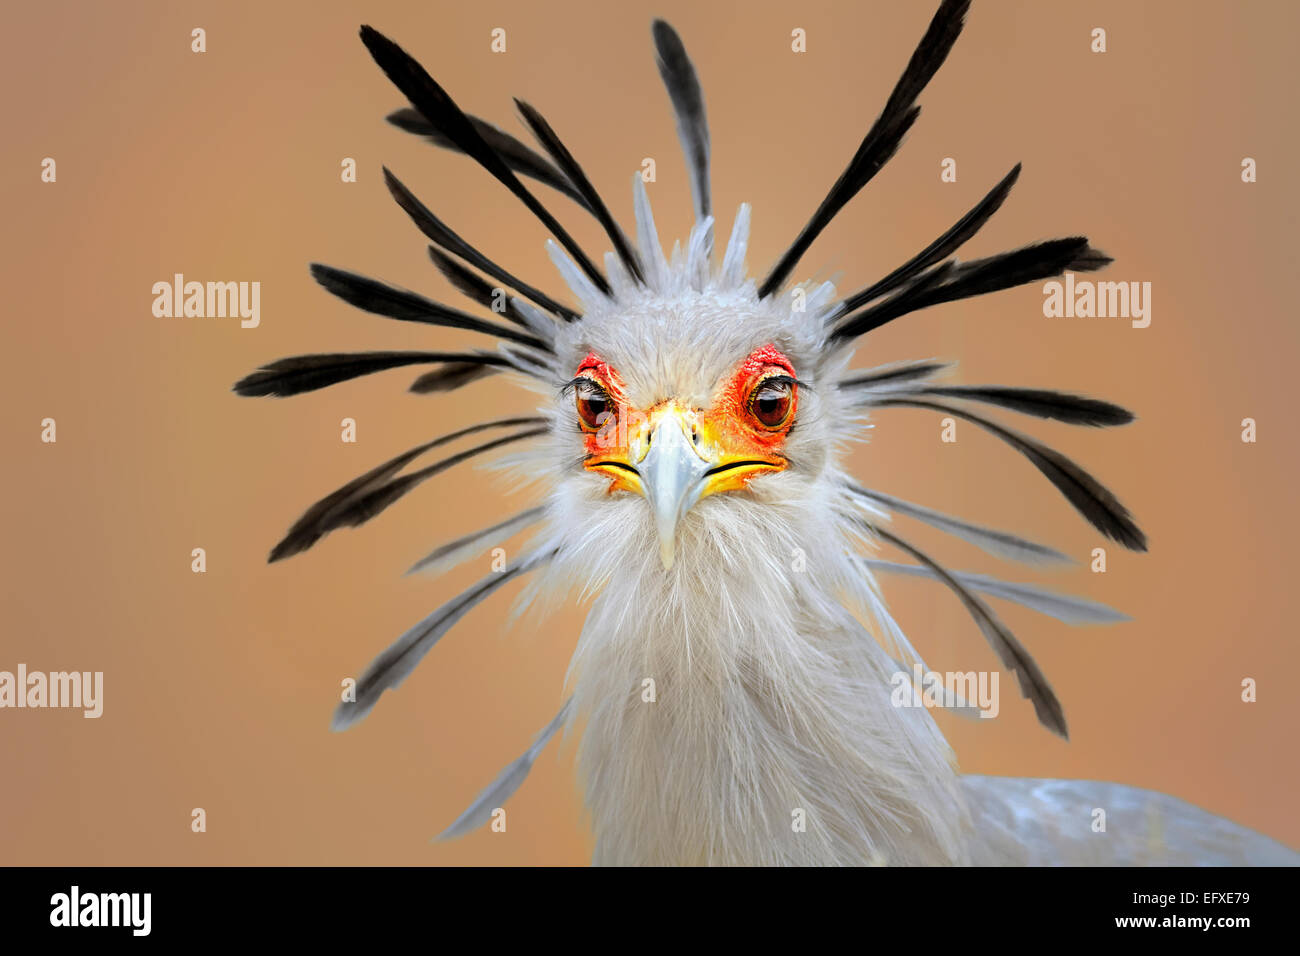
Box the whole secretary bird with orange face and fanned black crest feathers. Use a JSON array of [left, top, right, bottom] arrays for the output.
[[235, 0, 1296, 865]]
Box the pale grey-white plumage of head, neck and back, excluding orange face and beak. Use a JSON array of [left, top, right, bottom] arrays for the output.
[[488, 187, 1291, 865]]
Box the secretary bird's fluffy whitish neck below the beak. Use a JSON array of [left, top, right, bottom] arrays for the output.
[[572, 538, 967, 865]]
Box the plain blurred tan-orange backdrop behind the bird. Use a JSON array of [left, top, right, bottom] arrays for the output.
[[0, 0, 1300, 864]]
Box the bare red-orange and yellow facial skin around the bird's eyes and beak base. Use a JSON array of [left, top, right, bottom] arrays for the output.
[[575, 345, 798, 496]]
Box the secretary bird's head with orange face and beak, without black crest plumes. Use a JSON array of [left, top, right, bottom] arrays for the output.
[[554, 239, 829, 570]]
